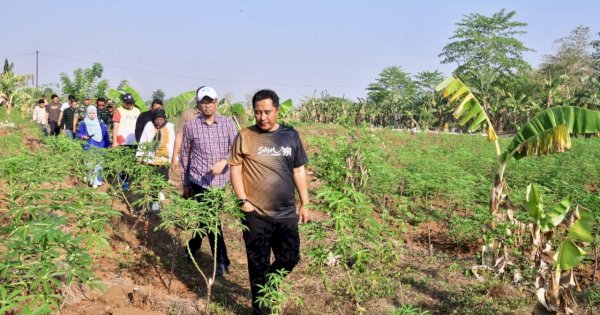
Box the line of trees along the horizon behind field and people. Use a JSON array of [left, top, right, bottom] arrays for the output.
[[0, 10, 600, 132]]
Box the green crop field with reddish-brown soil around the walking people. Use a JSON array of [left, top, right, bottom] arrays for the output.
[[0, 112, 600, 314]]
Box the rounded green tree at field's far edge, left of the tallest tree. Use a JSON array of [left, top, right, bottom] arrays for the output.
[[367, 66, 416, 127]]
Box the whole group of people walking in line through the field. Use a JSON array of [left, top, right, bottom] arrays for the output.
[[29, 86, 310, 314]]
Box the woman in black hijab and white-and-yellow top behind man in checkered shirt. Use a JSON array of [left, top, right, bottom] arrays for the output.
[[136, 108, 175, 211]]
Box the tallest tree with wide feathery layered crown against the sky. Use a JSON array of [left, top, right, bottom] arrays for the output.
[[439, 9, 533, 119]]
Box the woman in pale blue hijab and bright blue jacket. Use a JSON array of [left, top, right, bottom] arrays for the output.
[[77, 105, 110, 188]]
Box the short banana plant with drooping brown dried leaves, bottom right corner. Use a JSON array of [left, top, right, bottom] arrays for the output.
[[524, 184, 594, 314]]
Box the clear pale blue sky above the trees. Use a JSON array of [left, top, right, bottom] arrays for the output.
[[0, 0, 600, 101]]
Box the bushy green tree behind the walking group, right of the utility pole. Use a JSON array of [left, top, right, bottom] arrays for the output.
[[60, 62, 108, 100]]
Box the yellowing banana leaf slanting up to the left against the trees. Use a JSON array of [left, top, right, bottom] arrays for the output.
[[435, 75, 500, 155]]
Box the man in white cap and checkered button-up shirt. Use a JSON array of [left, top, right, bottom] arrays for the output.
[[180, 86, 237, 276]]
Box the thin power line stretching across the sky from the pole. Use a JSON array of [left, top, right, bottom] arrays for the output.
[[34, 51, 368, 88]]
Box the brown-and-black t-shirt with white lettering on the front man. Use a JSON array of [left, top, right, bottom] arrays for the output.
[[229, 125, 308, 219]]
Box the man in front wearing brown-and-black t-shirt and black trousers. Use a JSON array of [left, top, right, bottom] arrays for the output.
[[229, 90, 310, 314]]
